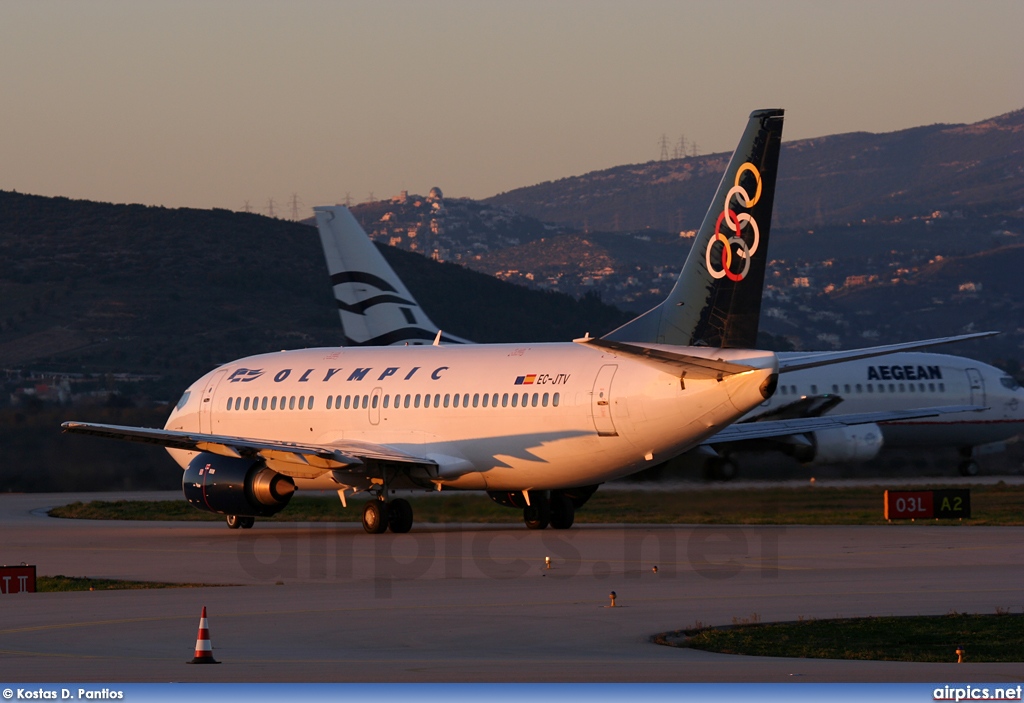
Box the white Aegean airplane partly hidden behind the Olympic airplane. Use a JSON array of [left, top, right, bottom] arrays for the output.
[[314, 156, 1024, 480]]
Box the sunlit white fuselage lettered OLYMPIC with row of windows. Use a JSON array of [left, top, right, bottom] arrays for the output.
[[166, 344, 777, 490]]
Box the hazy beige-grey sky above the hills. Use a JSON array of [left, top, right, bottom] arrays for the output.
[[0, 0, 1024, 215]]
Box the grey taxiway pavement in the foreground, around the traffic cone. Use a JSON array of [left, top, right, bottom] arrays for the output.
[[0, 493, 1024, 683]]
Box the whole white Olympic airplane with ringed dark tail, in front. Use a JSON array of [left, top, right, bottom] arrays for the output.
[[63, 109, 983, 533]]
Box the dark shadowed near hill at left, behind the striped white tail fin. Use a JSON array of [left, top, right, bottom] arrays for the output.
[[0, 192, 624, 405]]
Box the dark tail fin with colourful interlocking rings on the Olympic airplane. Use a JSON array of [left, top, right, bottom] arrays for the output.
[[604, 109, 783, 349]]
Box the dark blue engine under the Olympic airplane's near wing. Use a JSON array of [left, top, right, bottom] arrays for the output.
[[181, 452, 295, 518]]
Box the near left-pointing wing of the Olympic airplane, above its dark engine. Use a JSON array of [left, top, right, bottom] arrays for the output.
[[60, 423, 437, 478]]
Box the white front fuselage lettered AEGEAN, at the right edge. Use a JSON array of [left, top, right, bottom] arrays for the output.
[[765, 352, 1024, 446]]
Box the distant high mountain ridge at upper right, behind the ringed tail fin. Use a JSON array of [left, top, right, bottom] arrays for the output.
[[484, 109, 1024, 231]]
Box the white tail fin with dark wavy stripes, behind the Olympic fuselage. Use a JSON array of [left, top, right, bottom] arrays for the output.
[[313, 205, 466, 347]]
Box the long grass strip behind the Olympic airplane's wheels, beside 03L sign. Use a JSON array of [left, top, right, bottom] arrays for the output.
[[49, 483, 1024, 525]]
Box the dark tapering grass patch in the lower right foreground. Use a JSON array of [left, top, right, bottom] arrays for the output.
[[671, 611, 1024, 662]]
